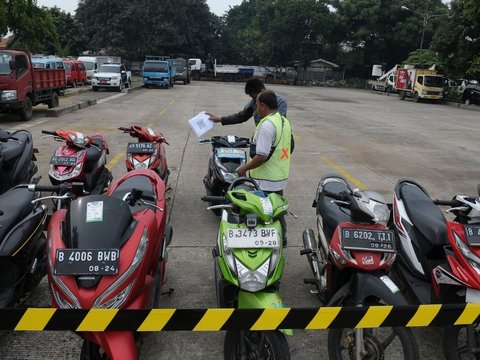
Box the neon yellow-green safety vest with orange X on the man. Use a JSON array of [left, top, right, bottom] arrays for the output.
[[250, 112, 292, 181]]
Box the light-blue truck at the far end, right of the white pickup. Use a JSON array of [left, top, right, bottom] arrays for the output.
[[142, 55, 176, 89]]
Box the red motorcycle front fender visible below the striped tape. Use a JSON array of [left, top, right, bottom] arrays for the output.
[[84, 331, 138, 360]]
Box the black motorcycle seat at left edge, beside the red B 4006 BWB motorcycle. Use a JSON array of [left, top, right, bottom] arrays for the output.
[[0, 188, 35, 242]]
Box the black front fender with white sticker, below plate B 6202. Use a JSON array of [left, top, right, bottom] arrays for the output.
[[327, 272, 408, 306]]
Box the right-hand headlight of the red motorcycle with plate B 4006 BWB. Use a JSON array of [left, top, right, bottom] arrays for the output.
[[93, 227, 148, 309]]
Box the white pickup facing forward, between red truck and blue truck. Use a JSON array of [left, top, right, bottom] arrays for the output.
[[92, 63, 132, 91]]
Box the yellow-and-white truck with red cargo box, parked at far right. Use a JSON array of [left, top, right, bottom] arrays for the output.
[[395, 65, 444, 102]]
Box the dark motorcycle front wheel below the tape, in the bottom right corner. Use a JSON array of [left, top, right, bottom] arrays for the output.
[[443, 324, 480, 360]]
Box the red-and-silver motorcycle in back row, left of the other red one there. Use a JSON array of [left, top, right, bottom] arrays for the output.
[[42, 130, 112, 194]]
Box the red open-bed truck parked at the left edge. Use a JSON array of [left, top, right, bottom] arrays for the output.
[[0, 49, 67, 121]]
